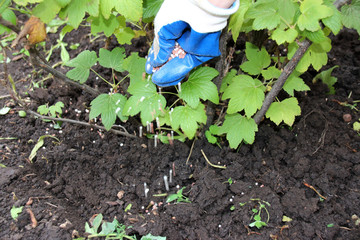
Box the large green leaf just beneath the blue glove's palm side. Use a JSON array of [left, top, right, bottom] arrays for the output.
[[179, 67, 219, 108]]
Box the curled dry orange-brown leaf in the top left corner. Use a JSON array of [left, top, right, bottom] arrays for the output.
[[11, 16, 46, 48]]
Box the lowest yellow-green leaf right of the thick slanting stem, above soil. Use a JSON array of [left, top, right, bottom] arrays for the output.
[[266, 97, 301, 126]]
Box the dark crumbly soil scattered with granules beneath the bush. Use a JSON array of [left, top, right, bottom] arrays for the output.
[[0, 23, 360, 240]]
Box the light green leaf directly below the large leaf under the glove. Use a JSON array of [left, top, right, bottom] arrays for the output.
[[171, 104, 206, 139]]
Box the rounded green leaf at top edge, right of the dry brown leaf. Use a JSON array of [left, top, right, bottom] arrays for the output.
[[33, 0, 61, 23]]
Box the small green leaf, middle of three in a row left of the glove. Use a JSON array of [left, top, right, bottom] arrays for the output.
[[99, 47, 126, 72]]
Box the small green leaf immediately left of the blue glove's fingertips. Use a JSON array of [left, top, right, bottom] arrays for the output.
[[123, 53, 146, 81]]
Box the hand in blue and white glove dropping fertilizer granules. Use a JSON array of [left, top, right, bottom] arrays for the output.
[[145, 0, 239, 87]]
